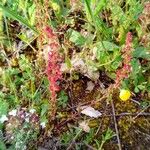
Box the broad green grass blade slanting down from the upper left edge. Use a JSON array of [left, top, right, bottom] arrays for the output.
[[0, 5, 38, 33]]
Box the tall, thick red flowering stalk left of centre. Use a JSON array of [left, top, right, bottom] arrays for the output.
[[45, 27, 62, 117]]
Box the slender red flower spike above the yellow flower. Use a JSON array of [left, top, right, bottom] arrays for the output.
[[115, 32, 132, 87]]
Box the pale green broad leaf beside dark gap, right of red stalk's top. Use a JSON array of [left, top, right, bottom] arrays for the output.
[[68, 29, 86, 46]]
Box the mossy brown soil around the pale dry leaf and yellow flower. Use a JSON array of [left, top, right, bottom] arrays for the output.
[[38, 76, 150, 150]]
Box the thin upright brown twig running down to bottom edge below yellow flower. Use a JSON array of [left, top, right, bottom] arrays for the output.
[[111, 100, 121, 150]]
